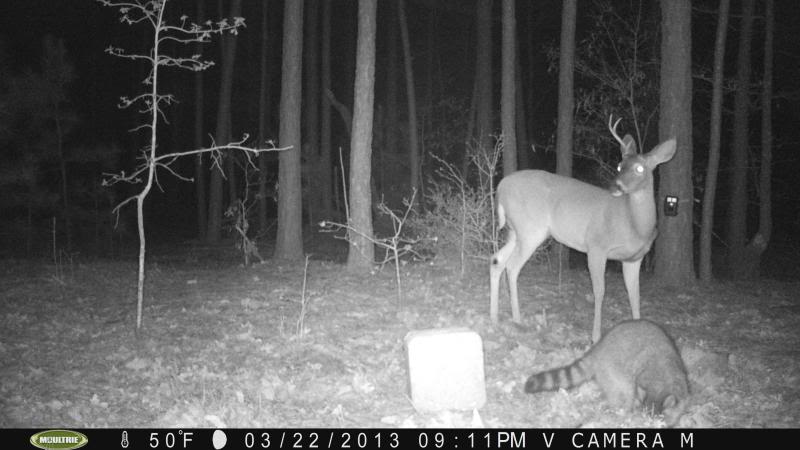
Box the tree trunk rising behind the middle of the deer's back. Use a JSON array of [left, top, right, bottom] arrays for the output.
[[556, 0, 578, 177]]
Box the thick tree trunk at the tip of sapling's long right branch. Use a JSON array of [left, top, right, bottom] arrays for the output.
[[275, 1, 303, 259]]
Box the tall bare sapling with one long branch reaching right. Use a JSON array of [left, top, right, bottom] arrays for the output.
[[97, 0, 288, 333]]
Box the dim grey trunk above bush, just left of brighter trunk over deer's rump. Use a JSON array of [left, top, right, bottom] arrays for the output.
[[475, 0, 493, 151]]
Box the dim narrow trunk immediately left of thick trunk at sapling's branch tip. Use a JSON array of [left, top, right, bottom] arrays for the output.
[[258, 0, 272, 233]]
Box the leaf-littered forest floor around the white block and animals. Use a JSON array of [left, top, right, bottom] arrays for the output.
[[0, 236, 800, 428]]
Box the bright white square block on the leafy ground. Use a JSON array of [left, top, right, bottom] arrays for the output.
[[405, 328, 486, 412]]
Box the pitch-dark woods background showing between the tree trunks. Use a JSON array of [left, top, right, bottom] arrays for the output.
[[0, 0, 800, 277]]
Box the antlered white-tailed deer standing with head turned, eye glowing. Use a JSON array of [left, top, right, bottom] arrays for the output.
[[489, 117, 675, 342]]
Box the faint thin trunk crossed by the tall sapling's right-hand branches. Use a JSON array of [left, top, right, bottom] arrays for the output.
[[194, 0, 208, 240]]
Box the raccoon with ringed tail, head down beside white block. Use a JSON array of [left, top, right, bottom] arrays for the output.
[[525, 319, 689, 426]]
